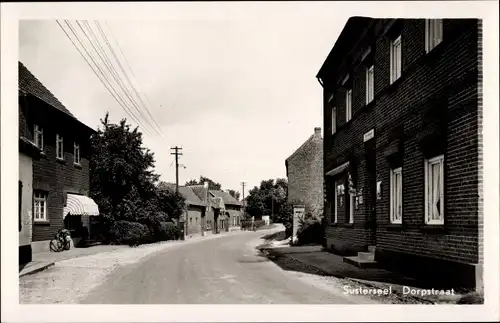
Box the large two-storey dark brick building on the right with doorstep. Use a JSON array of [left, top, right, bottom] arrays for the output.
[[317, 17, 483, 288]]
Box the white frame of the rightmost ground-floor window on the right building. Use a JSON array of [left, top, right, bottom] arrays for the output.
[[424, 155, 445, 225]]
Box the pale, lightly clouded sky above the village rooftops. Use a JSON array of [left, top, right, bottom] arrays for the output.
[[19, 3, 348, 193]]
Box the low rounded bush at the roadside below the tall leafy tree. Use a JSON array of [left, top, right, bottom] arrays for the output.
[[109, 221, 151, 246]]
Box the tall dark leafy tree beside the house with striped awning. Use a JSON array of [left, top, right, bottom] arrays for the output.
[[90, 113, 183, 227]]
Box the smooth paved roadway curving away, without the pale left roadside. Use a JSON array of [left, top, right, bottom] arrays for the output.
[[82, 232, 356, 304]]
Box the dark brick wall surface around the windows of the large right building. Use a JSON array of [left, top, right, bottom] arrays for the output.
[[324, 20, 482, 263]]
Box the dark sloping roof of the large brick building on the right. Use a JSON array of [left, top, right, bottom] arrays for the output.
[[316, 17, 373, 78]]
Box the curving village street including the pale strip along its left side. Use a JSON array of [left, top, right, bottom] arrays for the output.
[[20, 229, 370, 304]]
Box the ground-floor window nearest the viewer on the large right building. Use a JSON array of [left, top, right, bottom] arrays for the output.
[[424, 155, 444, 224]]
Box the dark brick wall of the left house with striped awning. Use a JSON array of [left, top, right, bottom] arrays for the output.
[[19, 96, 90, 241]]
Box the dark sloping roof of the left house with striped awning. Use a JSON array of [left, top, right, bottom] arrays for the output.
[[18, 62, 76, 119]]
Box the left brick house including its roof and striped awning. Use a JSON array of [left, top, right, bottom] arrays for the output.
[[18, 62, 99, 252]]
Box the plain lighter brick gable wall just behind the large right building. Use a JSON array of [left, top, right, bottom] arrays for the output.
[[285, 127, 324, 218]]
